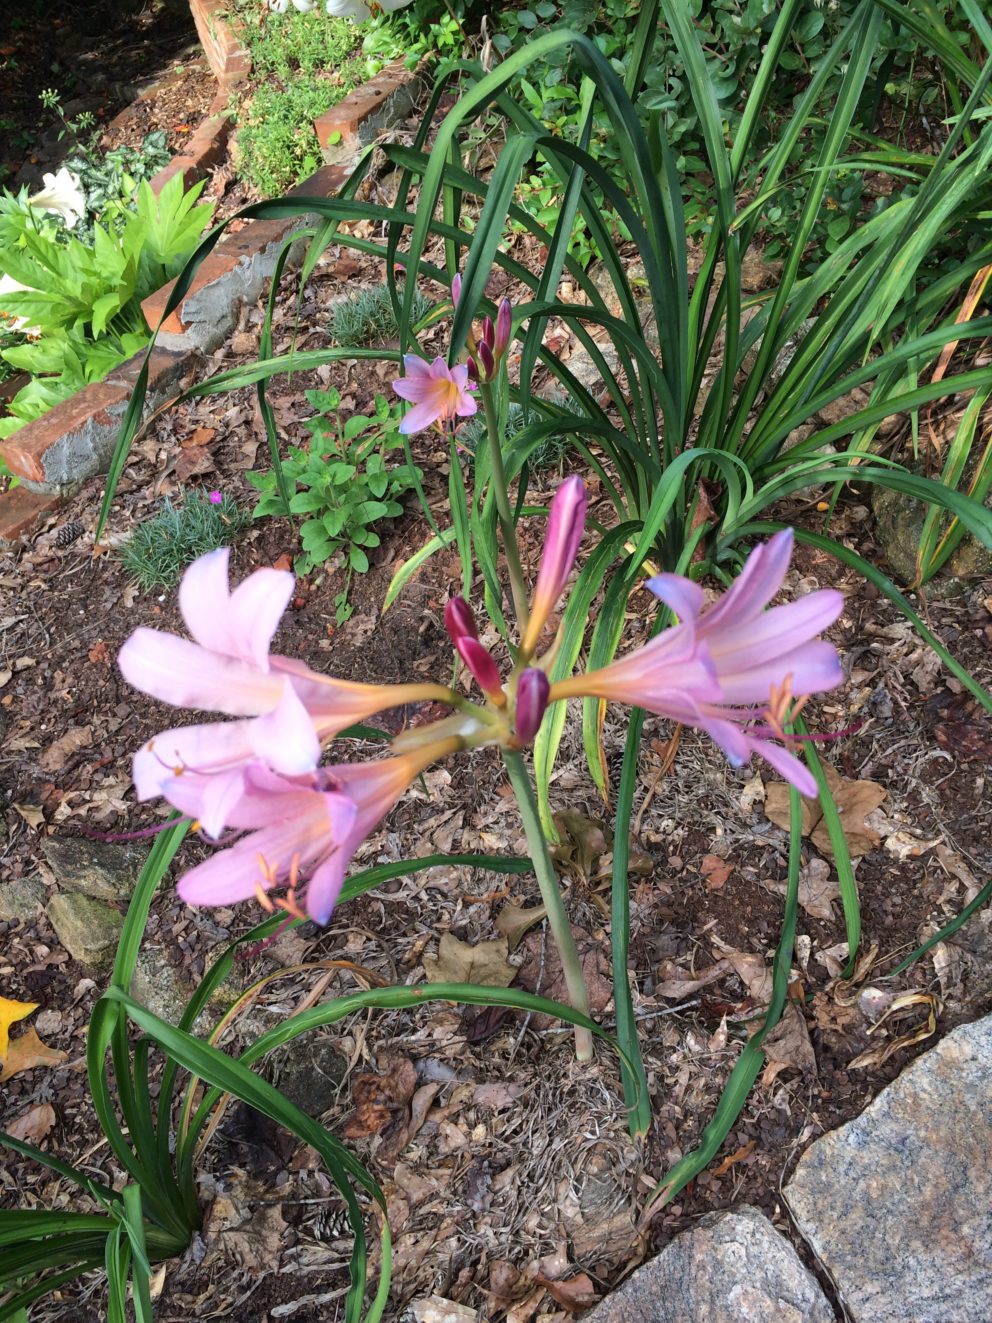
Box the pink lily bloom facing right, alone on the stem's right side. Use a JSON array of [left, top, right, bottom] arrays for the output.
[[550, 529, 844, 795]]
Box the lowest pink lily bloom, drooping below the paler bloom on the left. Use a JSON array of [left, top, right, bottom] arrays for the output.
[[169, 737, 463, 925]]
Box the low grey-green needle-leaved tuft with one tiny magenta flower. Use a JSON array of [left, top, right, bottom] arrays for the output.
[[120, 492, 251, 593]]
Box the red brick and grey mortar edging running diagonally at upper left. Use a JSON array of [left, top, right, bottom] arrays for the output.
[[0, 48, 419, 541]]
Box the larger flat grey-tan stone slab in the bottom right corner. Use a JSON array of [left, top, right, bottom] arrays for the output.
[[786, 1016, 992, 1323]]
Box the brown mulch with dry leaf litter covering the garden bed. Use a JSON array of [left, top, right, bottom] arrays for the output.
[[0, 240, 992, 1323]]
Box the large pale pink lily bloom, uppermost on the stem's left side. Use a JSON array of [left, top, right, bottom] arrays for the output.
[[118, 548, 451, 804]]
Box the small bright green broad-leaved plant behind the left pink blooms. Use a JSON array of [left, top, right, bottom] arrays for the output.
[[246, 389, 421, 624]]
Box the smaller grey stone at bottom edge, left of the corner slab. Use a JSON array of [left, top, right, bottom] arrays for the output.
[[583, 1204, 835, 1323]]
